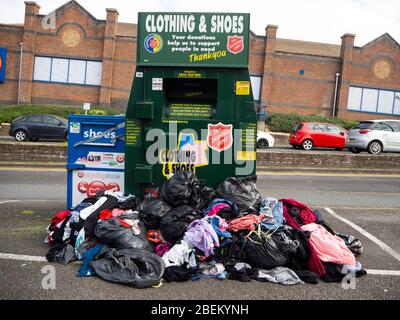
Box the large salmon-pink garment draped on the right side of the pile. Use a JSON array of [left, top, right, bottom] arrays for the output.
[[301, 223, 356, 267]]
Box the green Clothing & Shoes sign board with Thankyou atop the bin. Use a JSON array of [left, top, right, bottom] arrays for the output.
[[137, 12, 250, 68]]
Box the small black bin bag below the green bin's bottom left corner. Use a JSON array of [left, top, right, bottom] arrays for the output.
[[138, 198, 171, 230]]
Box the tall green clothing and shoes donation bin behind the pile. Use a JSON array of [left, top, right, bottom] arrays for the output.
[[125, 12, 257, 197]]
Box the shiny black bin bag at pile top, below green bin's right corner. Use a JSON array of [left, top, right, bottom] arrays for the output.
[[216, 176, 262, 215]]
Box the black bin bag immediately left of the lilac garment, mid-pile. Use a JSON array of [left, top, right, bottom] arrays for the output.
[[160, 206, 201, 244]]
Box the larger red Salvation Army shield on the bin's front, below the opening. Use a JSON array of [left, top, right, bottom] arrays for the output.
[[207, 122, 233, 152]]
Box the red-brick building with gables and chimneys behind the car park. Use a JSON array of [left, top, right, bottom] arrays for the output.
[[0, 1, 400, 120]]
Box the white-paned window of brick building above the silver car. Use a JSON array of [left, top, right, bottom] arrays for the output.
[[347, 87, 400, 115]]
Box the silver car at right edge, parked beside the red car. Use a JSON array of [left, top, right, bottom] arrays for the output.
[[346, 120, 400, 154]]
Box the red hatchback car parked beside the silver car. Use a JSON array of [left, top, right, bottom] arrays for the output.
[[289, 122, 347, 150]]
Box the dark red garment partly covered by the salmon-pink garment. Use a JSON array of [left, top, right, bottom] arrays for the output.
[[279, 199, 326, 276]]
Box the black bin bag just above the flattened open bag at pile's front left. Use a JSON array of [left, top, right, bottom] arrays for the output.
[[94, 213, 152, 251]]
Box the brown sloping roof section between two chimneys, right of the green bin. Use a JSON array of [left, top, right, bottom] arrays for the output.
[[276, 38, 341, 58]]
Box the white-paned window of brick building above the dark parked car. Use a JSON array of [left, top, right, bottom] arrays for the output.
[[33, 56, 102, 86]]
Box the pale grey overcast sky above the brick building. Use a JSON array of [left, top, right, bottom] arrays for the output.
[[0, 0, 400, 46]]
